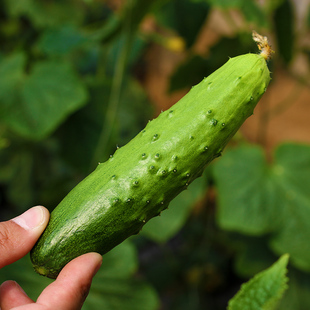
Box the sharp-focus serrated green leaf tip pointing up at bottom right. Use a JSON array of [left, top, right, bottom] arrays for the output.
[[228, 254, 289, 310]]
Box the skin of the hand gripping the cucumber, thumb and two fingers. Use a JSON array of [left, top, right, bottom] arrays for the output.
[[0, 206, 102, 310]]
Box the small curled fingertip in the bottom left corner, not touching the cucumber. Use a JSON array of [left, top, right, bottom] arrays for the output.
[[0, 281, 33, 310]]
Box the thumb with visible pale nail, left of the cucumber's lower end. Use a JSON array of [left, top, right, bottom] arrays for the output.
[[0, 206, 49, 268]]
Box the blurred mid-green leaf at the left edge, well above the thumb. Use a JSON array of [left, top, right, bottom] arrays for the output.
[[0, 60, 87, 140]]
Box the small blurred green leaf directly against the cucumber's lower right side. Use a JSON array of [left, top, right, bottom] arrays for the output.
[[141, 173, 206, 243]]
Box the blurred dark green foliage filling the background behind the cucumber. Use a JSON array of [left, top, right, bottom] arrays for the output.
[[0, 0, 310, 310]]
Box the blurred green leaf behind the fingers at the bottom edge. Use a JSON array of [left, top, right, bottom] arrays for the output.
[[0, 241, 158, 310]]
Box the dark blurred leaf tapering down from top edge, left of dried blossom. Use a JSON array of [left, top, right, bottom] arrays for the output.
[[155, 0, 210, 47]]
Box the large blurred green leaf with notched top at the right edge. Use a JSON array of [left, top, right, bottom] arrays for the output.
[[214, 144, 310, 271]]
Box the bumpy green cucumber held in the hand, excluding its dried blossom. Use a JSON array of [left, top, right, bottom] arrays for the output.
[[31, 54, 270, 278]]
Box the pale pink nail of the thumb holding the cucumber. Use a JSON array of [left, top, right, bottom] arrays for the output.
[[12, 206, 44, 230]]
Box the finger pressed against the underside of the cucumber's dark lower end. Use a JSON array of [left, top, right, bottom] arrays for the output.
[[37, 253, 102, 310]]
